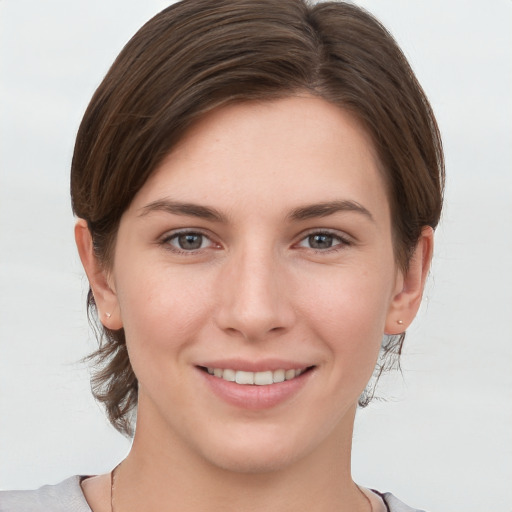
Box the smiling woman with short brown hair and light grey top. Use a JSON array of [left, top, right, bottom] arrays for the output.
[[0, 0, 443, 512]]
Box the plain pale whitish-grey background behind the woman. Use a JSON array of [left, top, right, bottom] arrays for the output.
[[0, 0, 512, 512]]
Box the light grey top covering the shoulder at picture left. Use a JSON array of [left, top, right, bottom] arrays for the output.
[[0, 476, 91, 512]]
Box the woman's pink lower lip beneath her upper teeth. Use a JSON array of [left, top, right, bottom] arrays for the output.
[[198, 369, 313, 410]]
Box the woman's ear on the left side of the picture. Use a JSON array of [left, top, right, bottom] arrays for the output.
[[75, 219, 123, 331]]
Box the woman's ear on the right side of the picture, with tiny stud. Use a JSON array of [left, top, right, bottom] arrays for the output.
[[385, 226, 434, 334]]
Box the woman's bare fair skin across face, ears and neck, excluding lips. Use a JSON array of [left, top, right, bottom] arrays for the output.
[[76, 96, 432, 512]]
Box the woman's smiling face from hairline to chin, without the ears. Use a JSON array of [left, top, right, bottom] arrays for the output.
[[104, 97, 403, 471]]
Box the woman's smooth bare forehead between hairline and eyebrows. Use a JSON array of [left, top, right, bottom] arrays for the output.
[[128, 96, 388, 221]]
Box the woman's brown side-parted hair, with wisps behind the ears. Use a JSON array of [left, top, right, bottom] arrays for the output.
[[71, 0, 444, 433]]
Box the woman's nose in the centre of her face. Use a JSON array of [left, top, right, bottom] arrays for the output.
[[216, 243, 294, 341]]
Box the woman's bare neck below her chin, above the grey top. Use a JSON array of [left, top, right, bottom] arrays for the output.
[[115, 402, 368, 512]]
